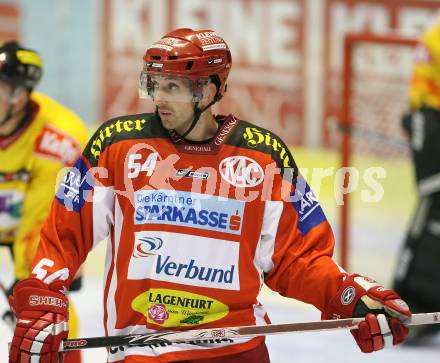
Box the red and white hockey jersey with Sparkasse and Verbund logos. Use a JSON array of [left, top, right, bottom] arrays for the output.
[[33, 114, 344, 362]]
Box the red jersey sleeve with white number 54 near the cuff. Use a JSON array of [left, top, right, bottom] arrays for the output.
[[31, 132, 114, 286]]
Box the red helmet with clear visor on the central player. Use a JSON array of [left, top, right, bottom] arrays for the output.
[[140, 28, 232, 102]]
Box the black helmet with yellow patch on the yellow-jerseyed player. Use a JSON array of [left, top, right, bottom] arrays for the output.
[[0, 41, 43, 91]]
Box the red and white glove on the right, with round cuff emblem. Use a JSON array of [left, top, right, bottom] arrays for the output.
[[322, 275, 411, 353]]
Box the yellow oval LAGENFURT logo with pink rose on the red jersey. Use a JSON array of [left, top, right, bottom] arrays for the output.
[[131, 289, 229, 327]]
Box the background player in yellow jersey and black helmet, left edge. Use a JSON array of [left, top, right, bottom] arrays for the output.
[[0, 41, 87, 363]]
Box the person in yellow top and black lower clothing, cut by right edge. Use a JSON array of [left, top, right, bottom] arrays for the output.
[[394, 17, 440, 345]]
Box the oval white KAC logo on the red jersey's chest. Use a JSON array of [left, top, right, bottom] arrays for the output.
[[218, 156, 264, 188]]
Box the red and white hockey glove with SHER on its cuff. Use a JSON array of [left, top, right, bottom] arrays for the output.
[[9, 278, 68, 363]]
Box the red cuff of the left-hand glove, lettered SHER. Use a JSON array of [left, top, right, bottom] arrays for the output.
[[9, 278, 69, 319]]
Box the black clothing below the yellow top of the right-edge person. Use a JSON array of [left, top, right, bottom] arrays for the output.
[[394, 107, 440, 313]]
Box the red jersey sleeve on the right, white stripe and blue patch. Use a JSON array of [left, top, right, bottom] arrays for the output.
[[258, 168, 346, 310]]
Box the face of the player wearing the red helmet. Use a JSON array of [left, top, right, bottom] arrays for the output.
[[151, 76, 194, 133]]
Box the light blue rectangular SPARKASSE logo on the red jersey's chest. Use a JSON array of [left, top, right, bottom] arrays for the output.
[[134, 190, 244, 234]]
